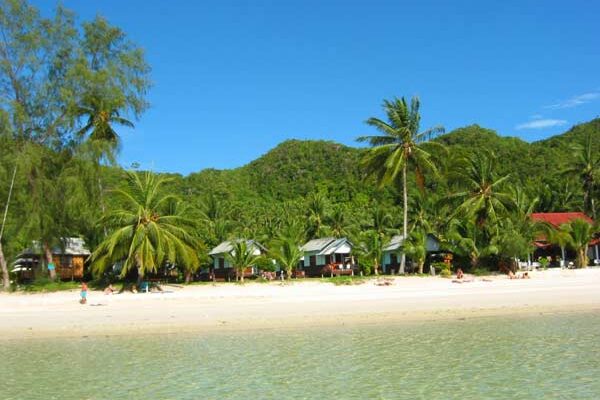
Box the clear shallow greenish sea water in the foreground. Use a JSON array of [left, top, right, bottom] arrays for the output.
[[0, 313, 600, 400]]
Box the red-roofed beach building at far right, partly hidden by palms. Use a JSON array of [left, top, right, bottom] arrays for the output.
[[531, 212, 600, 267]]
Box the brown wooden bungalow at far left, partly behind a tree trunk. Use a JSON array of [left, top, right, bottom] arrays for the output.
[[11, 237, 90, 281]]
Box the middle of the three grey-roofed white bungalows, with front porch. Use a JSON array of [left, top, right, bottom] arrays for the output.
[[301, 237, 357, 276]]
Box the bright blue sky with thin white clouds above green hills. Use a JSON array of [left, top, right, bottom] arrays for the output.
[[32, 0, 600, 174]]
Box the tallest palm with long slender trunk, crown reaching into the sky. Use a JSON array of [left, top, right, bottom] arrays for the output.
[[357, 97, 444, 273]]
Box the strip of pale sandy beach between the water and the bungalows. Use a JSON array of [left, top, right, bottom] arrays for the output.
[[0, 268, 600, 340]]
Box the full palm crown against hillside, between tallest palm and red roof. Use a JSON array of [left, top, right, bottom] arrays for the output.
[[447, 154, 514, 229]]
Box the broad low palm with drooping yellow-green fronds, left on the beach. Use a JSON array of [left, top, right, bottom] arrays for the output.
[[91, 172, 199, 281]]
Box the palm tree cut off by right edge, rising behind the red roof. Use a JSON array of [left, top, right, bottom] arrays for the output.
[[564, 132, 600, 220]]
